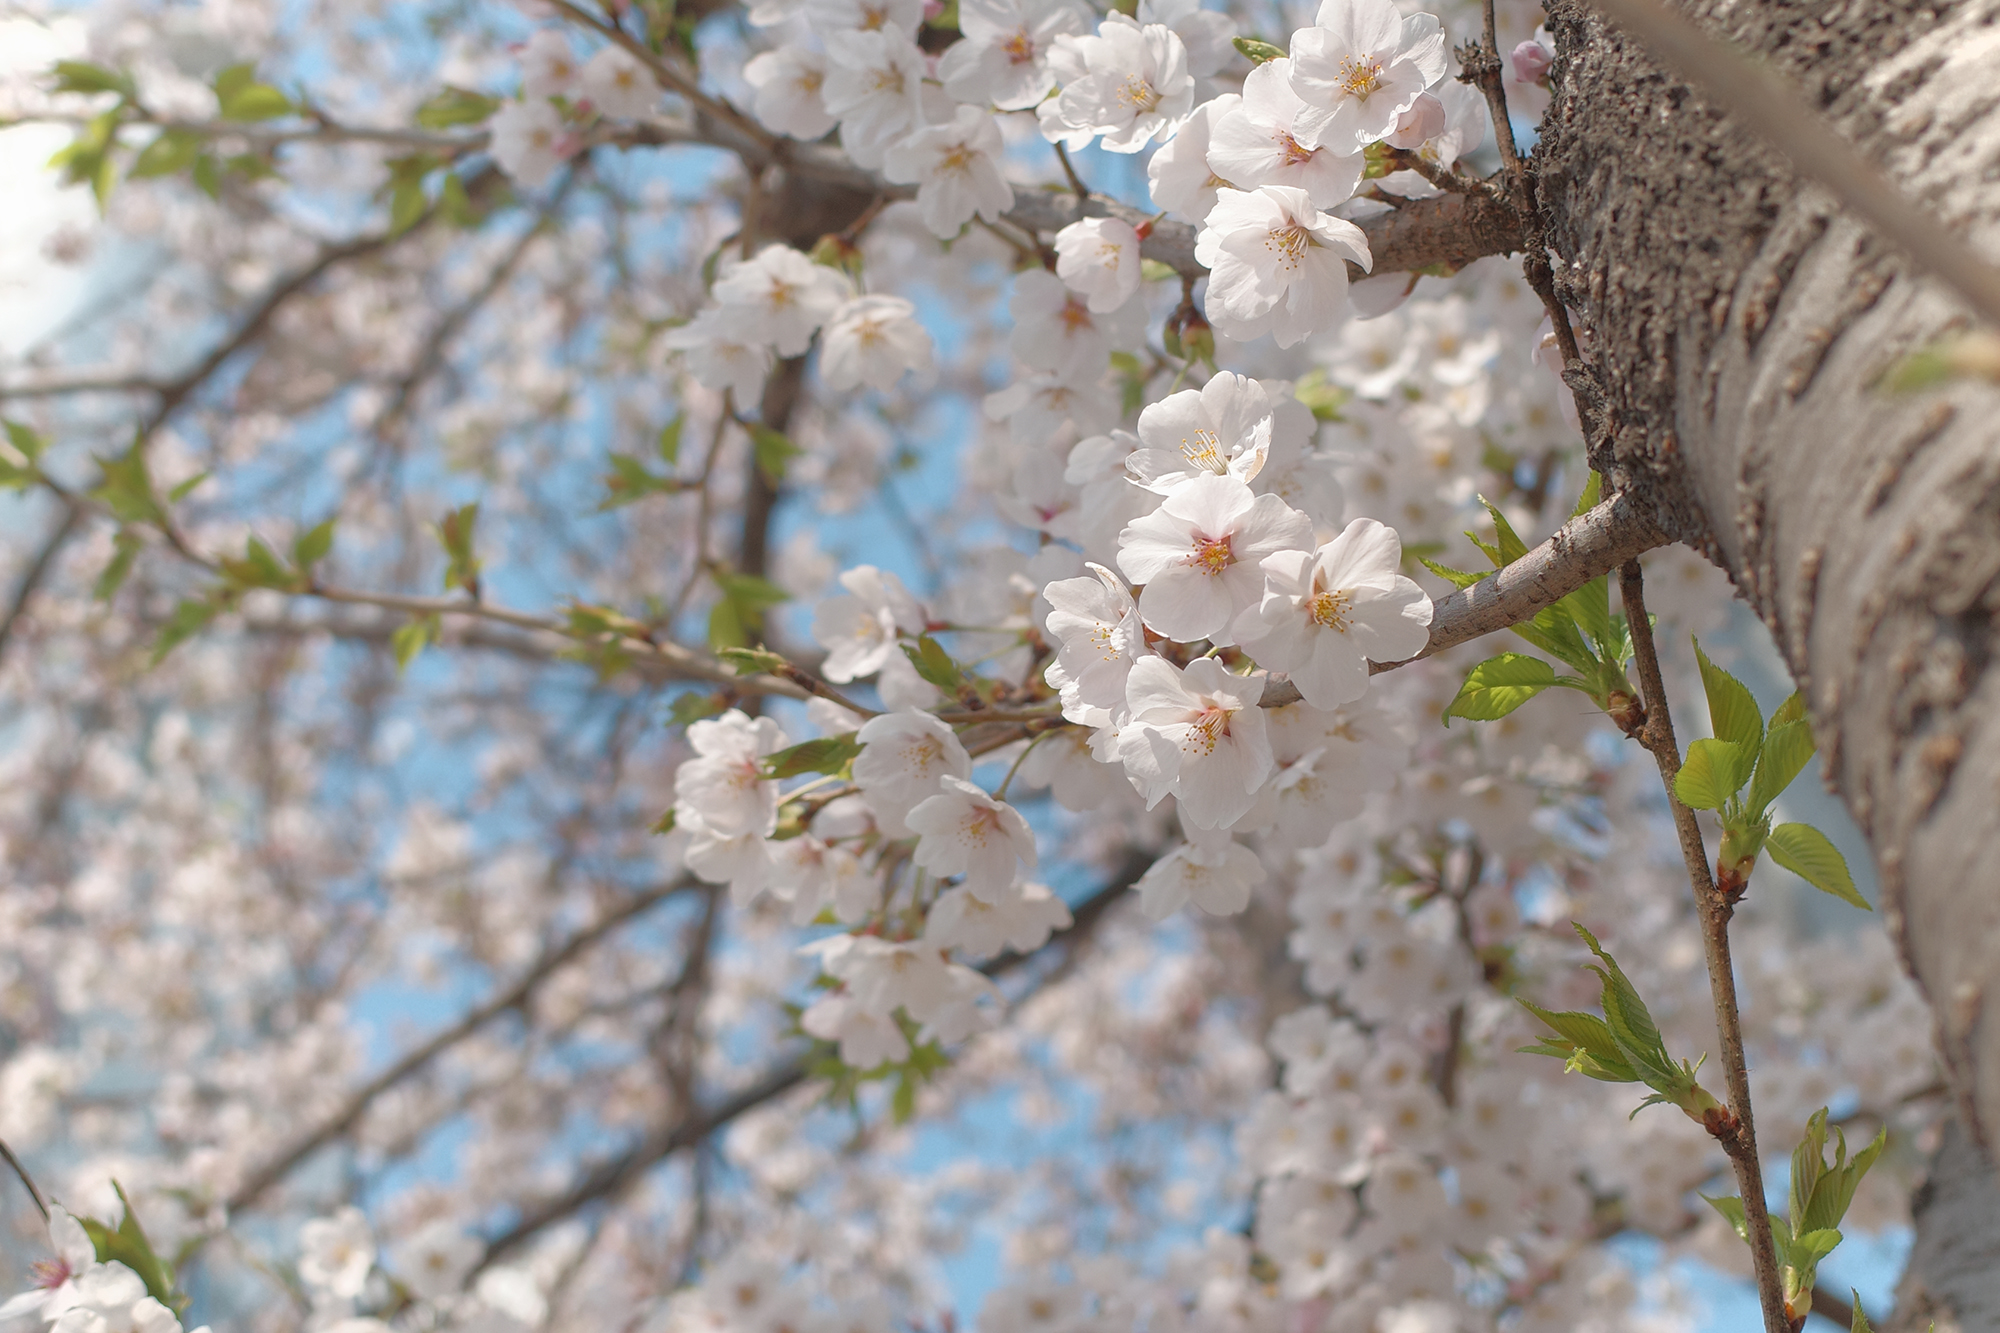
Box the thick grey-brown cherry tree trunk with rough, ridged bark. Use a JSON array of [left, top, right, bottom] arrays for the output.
[[1536, 0, 2000, 1331]]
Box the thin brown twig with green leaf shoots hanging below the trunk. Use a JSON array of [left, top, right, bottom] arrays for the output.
[[1618, 558, 1792, 1333]]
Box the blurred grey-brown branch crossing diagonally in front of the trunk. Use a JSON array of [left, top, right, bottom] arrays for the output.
[[1596, 0, 2000, 326]]
